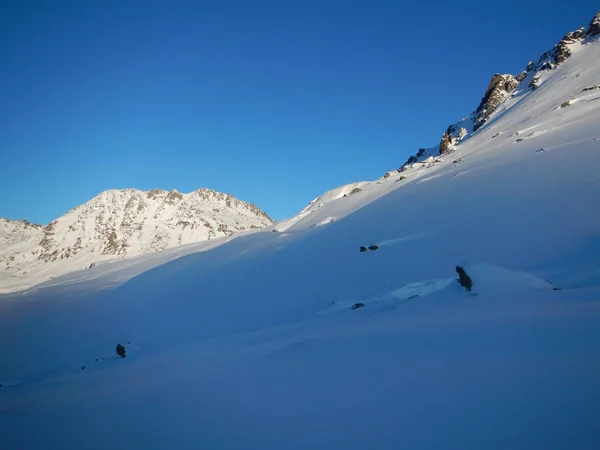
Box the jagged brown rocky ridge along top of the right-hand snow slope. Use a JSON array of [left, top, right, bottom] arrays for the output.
[[394, 11, 600, 172]]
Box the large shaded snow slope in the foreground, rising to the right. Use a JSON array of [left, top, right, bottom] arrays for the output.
[[0, 9, 600, 450]]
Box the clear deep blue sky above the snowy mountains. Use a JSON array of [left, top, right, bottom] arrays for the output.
[[0, 0, 598, 224]]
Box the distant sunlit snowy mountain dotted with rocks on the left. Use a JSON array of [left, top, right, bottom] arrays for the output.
[[0, 189, 273, 292]]
